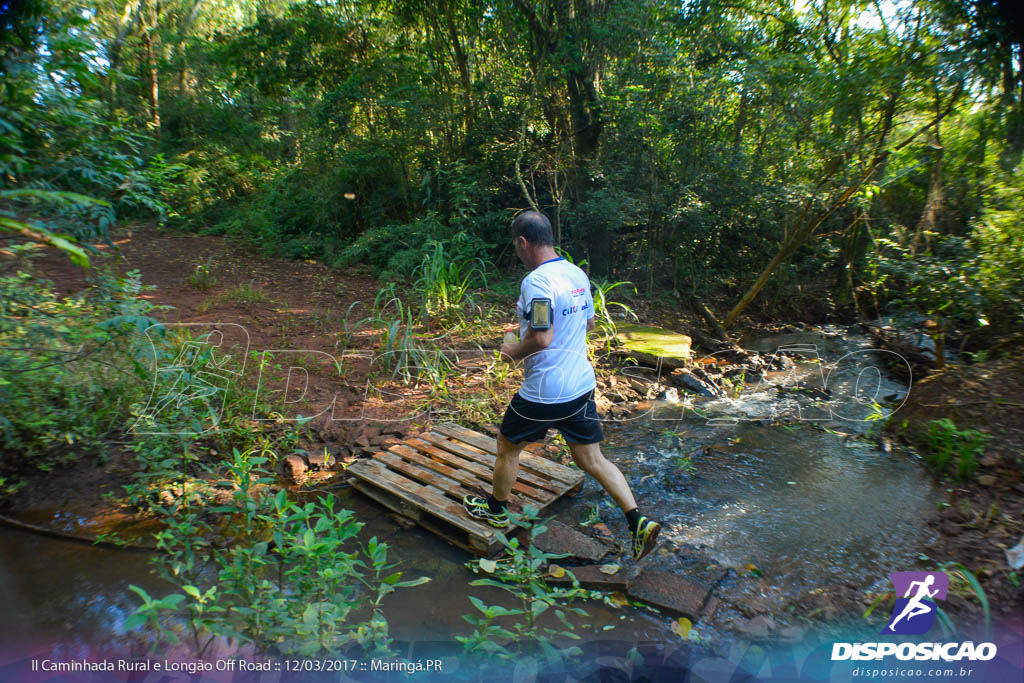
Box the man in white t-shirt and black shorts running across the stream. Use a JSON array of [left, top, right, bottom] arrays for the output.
[[463, 211, 662, 560]]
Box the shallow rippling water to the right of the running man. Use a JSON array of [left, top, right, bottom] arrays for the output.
[[567, 329, 939, 590]]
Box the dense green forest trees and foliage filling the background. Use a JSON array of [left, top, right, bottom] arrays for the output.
[[0, 0, 1024, 330]]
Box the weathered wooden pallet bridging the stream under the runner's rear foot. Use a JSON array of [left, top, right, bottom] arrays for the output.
[[345, 423, 584, 556]]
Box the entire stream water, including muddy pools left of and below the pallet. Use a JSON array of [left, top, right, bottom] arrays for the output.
[[0, 328, 941, 656]]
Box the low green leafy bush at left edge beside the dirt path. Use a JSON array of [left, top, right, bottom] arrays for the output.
[[0, 270, 161, 483]]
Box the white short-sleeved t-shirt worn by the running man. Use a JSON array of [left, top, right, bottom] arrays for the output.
[[515, 258, 596, 403]]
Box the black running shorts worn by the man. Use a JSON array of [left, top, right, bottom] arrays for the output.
[[501, 389, 604, 443]]
